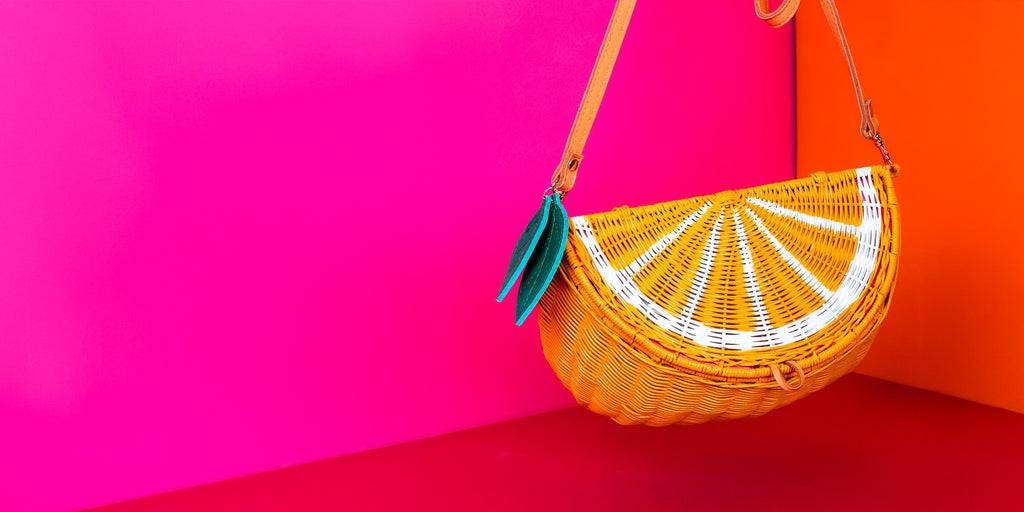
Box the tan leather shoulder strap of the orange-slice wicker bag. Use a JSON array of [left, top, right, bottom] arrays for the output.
[[551, 0, 895, 195]]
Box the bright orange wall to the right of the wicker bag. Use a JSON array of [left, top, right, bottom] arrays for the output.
[[797, 0, 1024, 413]]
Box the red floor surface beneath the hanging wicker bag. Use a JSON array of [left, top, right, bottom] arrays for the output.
[[95, 375, 1024, 512]]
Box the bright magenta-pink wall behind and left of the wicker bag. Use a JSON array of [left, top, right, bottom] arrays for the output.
[[0, 0, 794, 511]]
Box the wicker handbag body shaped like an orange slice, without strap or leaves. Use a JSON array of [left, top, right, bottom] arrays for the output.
[[540, 166, 899, 425]]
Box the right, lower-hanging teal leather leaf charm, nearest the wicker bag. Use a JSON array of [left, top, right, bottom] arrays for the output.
[[515, 194, 569, 326]]
